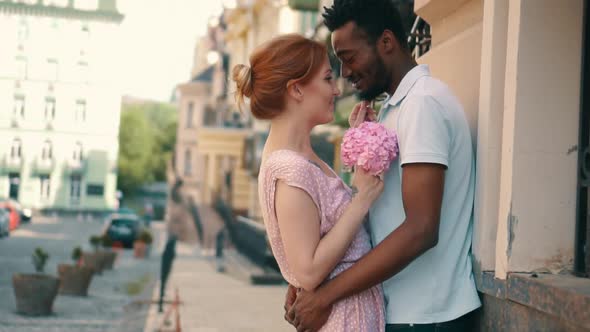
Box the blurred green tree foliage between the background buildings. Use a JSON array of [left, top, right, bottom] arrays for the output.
[[118, 102, 177, 195]]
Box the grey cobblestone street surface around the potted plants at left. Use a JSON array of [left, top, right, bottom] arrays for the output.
[[0, 218, 163, 332]]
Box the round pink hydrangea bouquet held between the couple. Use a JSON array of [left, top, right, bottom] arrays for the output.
[[341, 121, 398, 175]]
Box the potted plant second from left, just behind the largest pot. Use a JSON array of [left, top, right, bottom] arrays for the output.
[[57, 247, 94, 296]]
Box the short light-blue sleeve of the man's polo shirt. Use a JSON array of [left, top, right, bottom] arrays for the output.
[[397, 96, 452, 167]]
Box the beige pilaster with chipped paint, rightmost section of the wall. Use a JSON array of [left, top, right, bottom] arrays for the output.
[[496, 0, 583, 277]]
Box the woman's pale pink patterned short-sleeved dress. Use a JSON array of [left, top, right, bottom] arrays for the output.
[[258, 150, 385, 332]]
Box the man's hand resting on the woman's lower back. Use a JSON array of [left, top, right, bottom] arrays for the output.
[[288, 290, 332, 332]]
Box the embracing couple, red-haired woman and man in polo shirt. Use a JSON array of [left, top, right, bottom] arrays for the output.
[[233, 0, 481, 332]]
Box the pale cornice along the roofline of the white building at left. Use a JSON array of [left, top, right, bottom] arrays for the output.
[[0, 1, 125, 23]]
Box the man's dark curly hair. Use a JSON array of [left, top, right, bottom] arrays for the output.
[[322, 0, 408, 49]]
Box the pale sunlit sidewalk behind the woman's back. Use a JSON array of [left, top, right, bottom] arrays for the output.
[[144, 242, 294, 332]]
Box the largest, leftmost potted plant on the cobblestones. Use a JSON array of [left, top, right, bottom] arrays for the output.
[[12, 248, 59, 316]]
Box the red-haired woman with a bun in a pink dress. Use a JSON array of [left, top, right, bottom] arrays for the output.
[[233, 35, 385, 332]]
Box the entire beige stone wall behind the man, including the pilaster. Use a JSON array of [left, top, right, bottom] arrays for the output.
[[415, 0, 583, 278]]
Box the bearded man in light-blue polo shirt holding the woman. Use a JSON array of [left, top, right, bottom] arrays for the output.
[[285, 0, 481, 331]]
